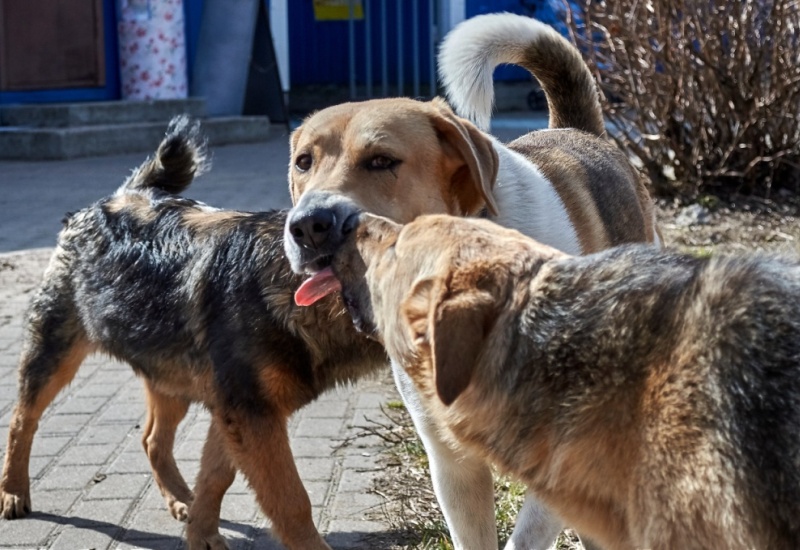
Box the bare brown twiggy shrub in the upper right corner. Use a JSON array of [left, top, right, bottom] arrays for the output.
[[566, 0, 800, 197]]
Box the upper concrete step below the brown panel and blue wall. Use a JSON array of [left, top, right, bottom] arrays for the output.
[[0, 98, 206, 128]]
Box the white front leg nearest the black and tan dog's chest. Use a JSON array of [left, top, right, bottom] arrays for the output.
[[392, 361, 500, 550]]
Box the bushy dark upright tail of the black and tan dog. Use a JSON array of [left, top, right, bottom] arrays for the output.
[[120, 115, 209, 194]]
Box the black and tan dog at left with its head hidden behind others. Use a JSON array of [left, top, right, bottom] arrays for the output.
[[0, 118, 386, 550]]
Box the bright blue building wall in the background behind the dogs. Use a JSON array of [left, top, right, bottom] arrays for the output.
[[0, 0, 559, 104]]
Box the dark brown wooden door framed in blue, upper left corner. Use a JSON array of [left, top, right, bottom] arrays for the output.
[[0, 0, 106, 91]]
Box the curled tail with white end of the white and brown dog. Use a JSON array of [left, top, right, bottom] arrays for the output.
[[439, 13, 605, 136]]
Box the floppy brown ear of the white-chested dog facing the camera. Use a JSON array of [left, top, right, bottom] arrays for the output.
[[432, 98, 500, 218]]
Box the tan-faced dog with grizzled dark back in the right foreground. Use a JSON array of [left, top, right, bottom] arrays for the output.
[[303, 215, 800, 550]]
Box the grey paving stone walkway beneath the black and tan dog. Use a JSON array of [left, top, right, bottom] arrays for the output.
[[0, 129, 397, 550]]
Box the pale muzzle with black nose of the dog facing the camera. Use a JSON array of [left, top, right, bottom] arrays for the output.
[[284, 192, 361, 273]]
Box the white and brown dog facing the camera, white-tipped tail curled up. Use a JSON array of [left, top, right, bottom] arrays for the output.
[[285, 14, 658, 549]]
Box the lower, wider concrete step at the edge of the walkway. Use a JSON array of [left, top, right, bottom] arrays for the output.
[[0, 115, 270, 160]]
